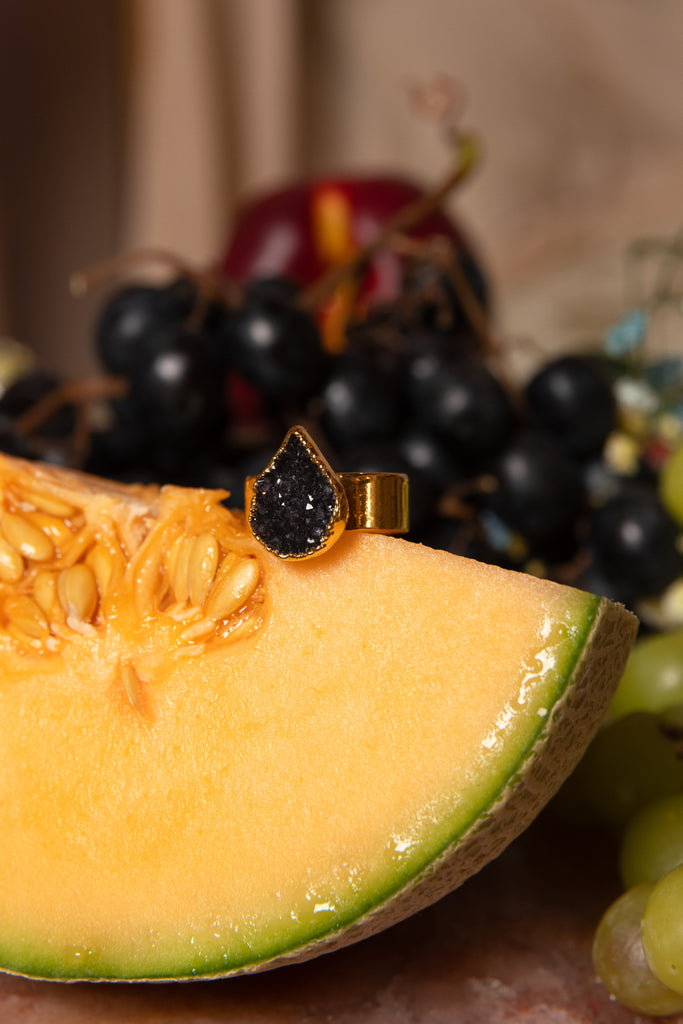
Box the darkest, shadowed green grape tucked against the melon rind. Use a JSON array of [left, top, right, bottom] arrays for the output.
[[555, 712, 683, 827]]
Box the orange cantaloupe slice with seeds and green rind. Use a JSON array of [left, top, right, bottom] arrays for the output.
[[0, 458, 635, 979]]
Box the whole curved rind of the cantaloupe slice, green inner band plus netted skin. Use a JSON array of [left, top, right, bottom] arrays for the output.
[[3, 595, 637, 982]]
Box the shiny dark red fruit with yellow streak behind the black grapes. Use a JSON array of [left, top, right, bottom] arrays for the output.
[[221, 176, 484, 302]]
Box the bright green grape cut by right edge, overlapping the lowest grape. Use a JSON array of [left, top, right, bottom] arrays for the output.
[[642, 865, 683, 995]]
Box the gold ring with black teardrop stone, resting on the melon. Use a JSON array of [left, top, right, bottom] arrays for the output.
[[245, 427, 409, 559]]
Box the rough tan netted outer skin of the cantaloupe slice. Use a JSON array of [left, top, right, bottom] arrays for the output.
[[198, 595, 638, 980]]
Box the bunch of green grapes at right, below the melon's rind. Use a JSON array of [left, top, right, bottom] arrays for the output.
[[563, 629, 683, 1016]]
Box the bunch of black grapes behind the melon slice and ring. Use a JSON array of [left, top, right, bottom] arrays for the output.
[[0, 250, 683, 606]]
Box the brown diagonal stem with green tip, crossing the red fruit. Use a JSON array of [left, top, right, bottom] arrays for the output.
[[299, 133, 479, 310]]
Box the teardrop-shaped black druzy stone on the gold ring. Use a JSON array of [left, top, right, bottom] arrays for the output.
[[249, 433, 339, 558]]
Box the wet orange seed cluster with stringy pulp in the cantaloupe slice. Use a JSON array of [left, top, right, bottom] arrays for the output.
[[0, 459, 264, 655]]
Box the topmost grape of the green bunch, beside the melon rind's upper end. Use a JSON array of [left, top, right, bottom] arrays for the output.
[[610, 630, 683, 718]]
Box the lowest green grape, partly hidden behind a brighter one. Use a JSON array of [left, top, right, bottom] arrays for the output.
[[593, 884, 683, 1017]]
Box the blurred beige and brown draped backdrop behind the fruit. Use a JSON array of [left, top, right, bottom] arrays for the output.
[[0, 0, 683, 374]]
